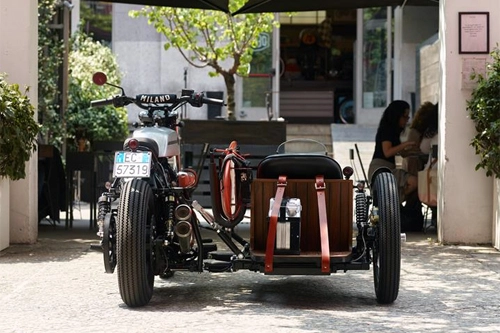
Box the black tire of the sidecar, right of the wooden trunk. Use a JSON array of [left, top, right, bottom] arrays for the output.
[[373, 172, 401, 304]]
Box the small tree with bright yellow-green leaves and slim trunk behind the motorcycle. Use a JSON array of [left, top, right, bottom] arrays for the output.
[[130, 0, 277, 120]]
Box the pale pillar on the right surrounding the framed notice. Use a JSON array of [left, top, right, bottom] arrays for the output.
[[438, 0, 500, 243]]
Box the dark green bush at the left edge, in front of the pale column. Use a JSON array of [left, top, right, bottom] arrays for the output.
[[0, 74, 40, 180]]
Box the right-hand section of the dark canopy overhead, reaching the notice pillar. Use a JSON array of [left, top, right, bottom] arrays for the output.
[[233, 0, 439, 15]]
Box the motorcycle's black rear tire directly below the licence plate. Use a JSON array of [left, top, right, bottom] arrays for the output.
[[116, 179, 154, 307]]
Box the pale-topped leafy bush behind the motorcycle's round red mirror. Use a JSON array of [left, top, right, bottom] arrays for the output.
[[65, 33, 128, 150]]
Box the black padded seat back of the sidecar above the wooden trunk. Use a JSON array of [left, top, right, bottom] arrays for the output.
[[257, 154, 342, 179]]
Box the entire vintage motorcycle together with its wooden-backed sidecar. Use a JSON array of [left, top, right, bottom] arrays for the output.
[[92, 73, 401, 307]]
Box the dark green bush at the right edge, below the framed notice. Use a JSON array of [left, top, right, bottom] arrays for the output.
[[467, 48, 500, 178]]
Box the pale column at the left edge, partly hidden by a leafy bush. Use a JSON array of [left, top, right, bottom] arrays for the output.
[[0, 0, 38, 243]]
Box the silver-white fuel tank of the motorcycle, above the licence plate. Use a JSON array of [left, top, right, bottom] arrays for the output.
[[132, 127, 181, 157]]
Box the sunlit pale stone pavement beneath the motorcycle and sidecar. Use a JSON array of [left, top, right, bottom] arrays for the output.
[[0, 209, 500, 332]]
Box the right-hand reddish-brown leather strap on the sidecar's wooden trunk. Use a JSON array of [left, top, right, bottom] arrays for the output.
[[314, 176, 330, 273]]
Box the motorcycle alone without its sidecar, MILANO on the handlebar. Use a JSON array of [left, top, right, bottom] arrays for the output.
[[91, 73, 232, 307]]
